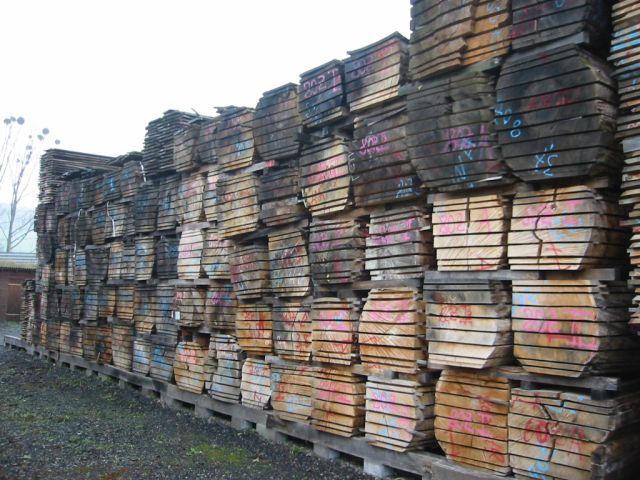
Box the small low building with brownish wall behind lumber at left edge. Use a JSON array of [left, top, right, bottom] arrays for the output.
[[0, 253, 37, 322]]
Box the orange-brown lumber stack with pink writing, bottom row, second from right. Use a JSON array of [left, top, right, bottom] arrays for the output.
[[435, 369, 511, 475]]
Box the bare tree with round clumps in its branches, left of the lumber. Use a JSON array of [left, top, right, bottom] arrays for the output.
[[0, 117, 60, 252]]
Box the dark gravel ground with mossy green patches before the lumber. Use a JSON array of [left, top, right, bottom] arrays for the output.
[[0, 325, 372, 480]]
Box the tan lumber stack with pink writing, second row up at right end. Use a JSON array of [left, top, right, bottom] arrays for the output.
[[512, 279, 640, 377]]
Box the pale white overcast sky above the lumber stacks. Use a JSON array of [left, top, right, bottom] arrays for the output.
[[0, 0, 410, 161]]
